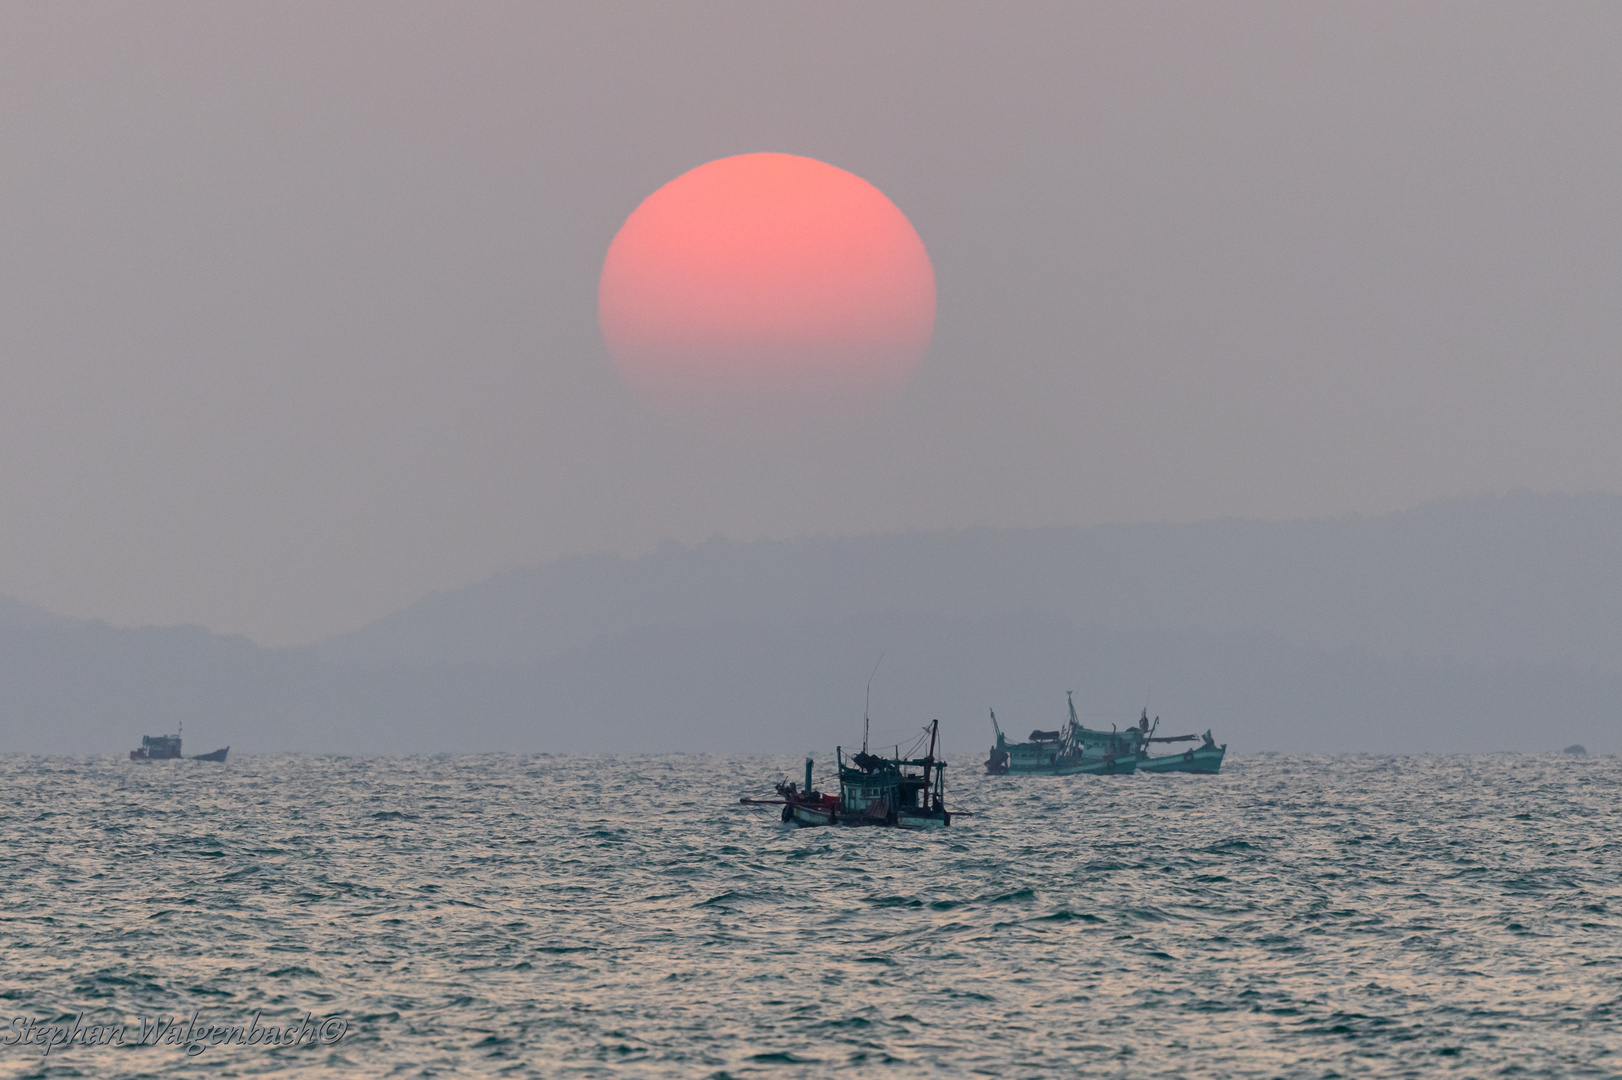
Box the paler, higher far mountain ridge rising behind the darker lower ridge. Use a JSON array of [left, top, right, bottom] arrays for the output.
[[316, 495, 1622, 671]]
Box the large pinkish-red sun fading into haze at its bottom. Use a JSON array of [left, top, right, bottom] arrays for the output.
[[597, 154, 934, 407]]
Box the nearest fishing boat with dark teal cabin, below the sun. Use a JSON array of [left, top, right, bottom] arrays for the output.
[[738, 720, 952, 829]]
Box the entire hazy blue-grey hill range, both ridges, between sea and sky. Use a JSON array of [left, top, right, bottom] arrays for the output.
[[0, 496, 1622, 752]]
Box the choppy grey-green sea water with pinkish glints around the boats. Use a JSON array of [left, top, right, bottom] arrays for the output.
[[0, 756, 1622, 1077]]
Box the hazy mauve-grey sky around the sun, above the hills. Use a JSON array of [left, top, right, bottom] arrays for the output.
[[0, 0, 1622, 644]]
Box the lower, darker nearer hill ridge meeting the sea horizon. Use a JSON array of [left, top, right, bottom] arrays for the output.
[[0, 600, 1622, 752]]
